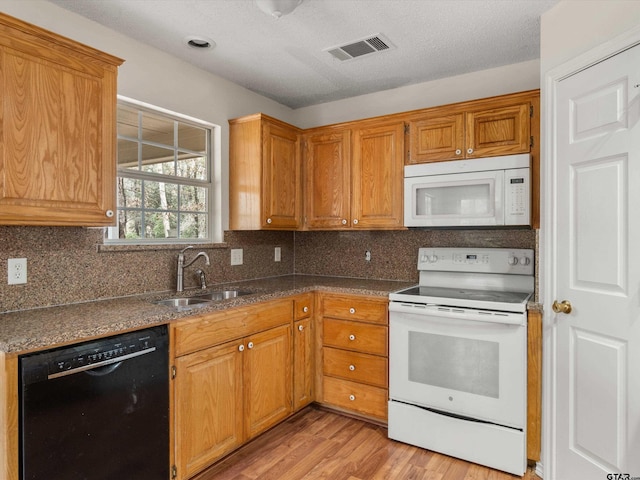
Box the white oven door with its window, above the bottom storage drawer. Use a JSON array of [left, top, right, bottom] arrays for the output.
[[389, 311, 527, 428]]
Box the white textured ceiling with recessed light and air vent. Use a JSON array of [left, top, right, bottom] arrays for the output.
[[50, 0, 558, 108]]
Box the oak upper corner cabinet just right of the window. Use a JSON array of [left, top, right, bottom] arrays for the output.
[[229, 114, 301, 230]]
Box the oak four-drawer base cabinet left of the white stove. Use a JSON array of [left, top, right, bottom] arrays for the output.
[[318, 294, 389, 423]]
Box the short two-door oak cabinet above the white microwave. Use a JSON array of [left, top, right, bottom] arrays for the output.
[[406, 94, 535, 164]]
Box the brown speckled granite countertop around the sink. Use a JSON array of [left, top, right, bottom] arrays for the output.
[[0, 275, 413, 353]]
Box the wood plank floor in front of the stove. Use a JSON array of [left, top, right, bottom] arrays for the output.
[[193, 407, 540, 480]]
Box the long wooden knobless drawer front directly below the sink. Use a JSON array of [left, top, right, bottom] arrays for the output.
[[174, 300, 293, 357]]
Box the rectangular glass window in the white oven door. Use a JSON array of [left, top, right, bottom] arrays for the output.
[[408, 331, 500, 399]]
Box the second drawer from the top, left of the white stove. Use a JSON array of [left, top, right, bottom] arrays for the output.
[[323, 318, 387, 356]]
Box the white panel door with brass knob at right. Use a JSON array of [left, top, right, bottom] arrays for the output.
[[549, 46, 640, 480]]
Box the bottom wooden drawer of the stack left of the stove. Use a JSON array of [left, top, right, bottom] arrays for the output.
[[322, 377, 388, 420]]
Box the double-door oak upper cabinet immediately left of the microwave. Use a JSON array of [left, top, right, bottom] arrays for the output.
[[304, 121, 404, 230]]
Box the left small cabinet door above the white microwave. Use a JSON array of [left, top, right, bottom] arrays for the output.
[[407, 113, 464, 163]]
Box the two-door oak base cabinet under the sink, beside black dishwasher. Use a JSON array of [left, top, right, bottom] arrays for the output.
[[173, 299, 293, 479]]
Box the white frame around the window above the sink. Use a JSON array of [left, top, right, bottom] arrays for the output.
[[104, 95, 222, 245]]
